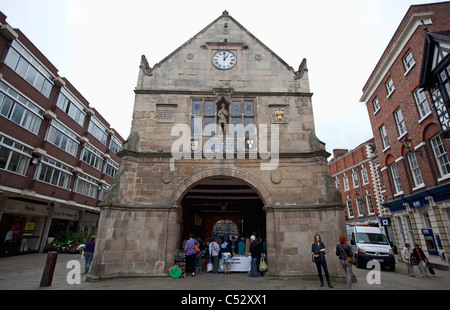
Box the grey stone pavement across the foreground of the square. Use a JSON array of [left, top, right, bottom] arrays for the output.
[[0, 253, 450, 293]]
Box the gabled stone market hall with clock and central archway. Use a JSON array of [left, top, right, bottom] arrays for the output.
[[89, 11, 345, 280]]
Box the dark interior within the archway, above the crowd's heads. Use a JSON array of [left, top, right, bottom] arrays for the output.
[[181, 178, 266, 245]]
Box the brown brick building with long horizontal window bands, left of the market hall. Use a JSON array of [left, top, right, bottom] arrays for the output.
[[0, 12, 124, 255]]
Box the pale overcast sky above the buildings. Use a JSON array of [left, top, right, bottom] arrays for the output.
[[0, 0, 439, 159]]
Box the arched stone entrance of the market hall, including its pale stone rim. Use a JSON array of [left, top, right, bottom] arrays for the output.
[[169, 168, 273, 266]]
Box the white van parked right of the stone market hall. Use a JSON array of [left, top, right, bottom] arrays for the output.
[[347, 226, 395, 271]]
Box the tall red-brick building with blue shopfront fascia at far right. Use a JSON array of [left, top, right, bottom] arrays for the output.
[[360, 2, 450, 264]]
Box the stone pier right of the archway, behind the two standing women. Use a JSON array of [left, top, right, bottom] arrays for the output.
[[265, 203, 346, 280]]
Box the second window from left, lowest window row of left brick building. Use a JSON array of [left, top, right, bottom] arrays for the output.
[[36, 156, 73, 189]]
